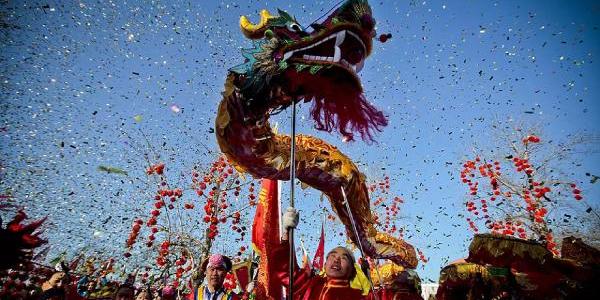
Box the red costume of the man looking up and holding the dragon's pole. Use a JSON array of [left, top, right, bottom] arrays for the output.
[[271, 241, 367, 300]]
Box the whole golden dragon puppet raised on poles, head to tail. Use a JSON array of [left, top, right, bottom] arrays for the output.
[[215, 0, 417, 268]]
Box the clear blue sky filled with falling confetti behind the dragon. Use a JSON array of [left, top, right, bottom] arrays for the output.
[[0, 1, 600, 280]]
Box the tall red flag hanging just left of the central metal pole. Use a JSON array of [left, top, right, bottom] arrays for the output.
[[252, 179, 283, 300]]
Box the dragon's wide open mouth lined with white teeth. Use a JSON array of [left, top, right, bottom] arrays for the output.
[[283, 29, 367, 75]]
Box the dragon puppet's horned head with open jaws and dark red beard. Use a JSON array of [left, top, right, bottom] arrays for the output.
[[230, 0, 387, 141]]
